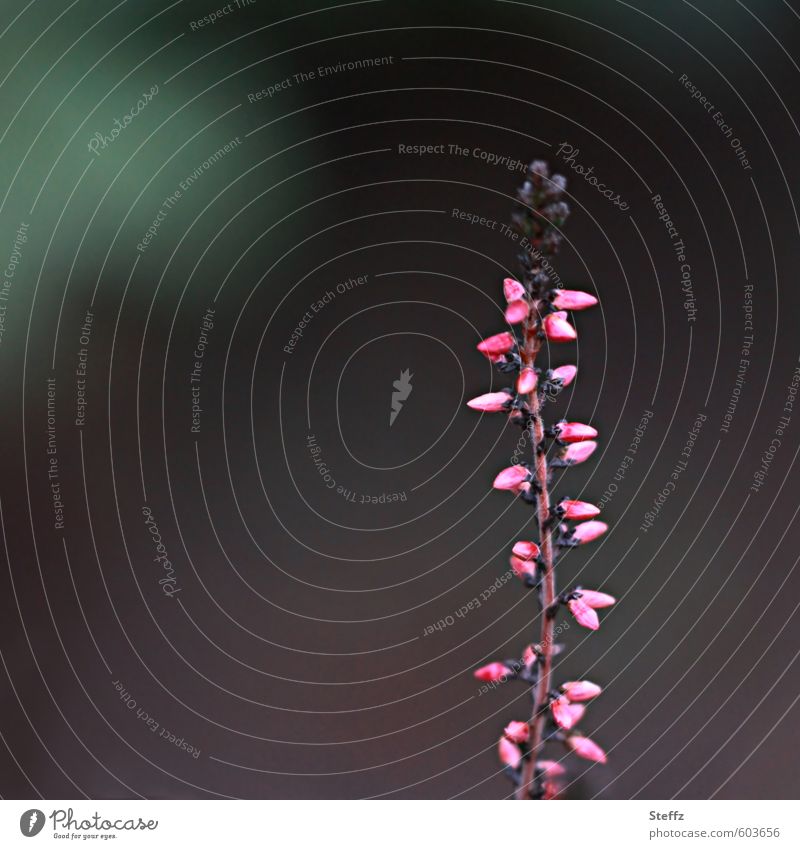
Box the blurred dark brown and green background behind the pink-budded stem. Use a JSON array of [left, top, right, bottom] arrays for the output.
[[0, 0, 800, 799]]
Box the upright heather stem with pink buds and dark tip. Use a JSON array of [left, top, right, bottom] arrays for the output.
[[468, 162, 615, 799]]
